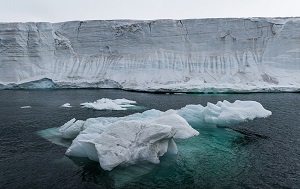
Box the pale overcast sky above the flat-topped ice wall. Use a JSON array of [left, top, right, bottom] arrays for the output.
[[0, 0, 300, 22]]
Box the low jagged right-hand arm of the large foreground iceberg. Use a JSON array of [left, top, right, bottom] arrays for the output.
[[178, 100, 272, 126]]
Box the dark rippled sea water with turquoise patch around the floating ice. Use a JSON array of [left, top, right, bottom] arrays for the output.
[[0, 90, 300, 189]]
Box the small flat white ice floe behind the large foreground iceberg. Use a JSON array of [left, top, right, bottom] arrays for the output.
[[80, 98, 136, 110]]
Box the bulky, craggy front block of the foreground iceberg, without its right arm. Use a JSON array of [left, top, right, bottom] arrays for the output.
[[59, 110, 199, 170]]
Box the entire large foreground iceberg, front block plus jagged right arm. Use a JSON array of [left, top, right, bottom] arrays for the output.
[[59, 101, 271, 170]]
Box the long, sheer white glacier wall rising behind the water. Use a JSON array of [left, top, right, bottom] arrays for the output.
[[0, 18, 300, 92]]
